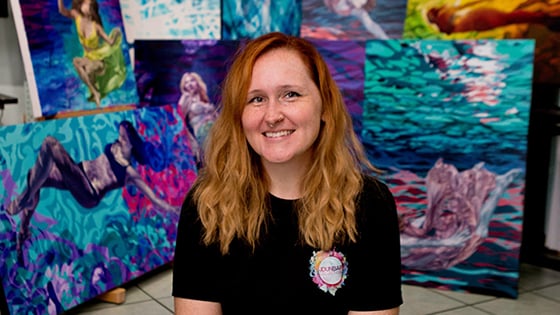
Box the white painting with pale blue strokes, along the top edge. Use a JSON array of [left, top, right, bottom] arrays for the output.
[[120, 0, 221, 43]]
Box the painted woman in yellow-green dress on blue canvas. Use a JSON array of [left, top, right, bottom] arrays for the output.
[[58, 0, 126, 107]]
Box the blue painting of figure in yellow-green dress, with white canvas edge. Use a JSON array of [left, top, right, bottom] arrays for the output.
[[11, 0, 138, 117]]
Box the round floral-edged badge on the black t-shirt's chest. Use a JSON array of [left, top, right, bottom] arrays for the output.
[[309, 250, 348, 295]]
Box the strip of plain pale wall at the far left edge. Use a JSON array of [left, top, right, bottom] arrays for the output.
[[0, 2, 27, 125]]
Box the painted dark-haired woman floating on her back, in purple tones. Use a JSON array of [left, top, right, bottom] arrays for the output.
[[6, 121, 179, 260]]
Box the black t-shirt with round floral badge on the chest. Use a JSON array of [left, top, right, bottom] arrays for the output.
[[172, 177, 402, 315]]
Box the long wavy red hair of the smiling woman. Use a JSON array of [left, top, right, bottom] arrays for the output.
[[193, 32, 379, 254]]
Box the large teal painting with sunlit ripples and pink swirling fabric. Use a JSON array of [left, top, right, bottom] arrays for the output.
[[361, 39, 534, 297]]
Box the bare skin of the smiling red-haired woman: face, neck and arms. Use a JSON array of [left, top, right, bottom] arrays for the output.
[[174, 48, 399, 315]]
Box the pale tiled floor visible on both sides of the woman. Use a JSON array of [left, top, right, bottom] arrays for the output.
[[54, 264, 560, 315]]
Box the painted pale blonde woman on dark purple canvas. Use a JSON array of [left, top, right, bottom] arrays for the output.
[[178, 72, 217, 164]]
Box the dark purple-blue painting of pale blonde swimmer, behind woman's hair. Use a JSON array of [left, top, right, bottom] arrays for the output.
[[135, 40, 240, 165]]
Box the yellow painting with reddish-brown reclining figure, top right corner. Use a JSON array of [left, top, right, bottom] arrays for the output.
[[403, 0, 560, 85]]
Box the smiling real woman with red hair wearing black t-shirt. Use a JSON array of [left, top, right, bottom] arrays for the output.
[[173, 33, 402, 315]]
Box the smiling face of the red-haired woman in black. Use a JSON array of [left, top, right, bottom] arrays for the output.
[[241, 48, 322, 166]]
